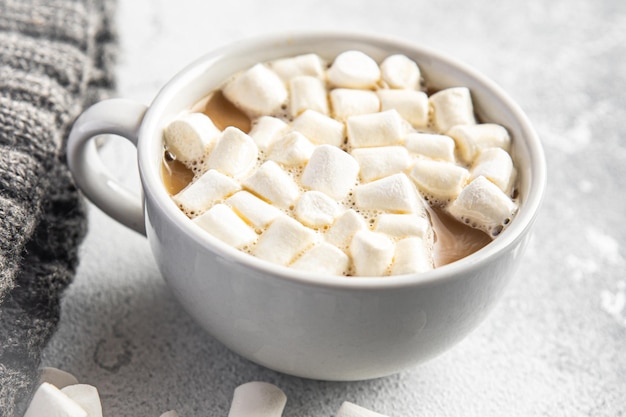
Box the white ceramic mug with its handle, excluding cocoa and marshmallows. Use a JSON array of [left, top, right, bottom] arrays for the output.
[[68, 32, 546, 380]]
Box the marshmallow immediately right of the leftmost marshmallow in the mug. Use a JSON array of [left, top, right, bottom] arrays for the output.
[[206, 126, 259, 179]]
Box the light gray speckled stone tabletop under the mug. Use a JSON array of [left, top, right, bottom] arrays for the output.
[[44, 0, 626, 417]]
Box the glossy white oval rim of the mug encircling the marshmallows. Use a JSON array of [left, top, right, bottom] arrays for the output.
[[137, 31, 546, 290]]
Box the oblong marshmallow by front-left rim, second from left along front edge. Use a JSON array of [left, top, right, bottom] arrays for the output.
[[193, 203, 258, 249]]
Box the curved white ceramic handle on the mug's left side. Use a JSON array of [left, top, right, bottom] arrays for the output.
[[67, 99, 148, 235]]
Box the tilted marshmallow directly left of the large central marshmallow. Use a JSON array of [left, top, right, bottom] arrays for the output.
[[243, 161, 300, 209]]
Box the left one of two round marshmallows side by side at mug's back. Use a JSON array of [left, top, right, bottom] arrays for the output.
[[327, 51, 380, 89]]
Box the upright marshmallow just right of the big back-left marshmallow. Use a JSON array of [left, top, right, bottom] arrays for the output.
[[289, 75, 329, 117]]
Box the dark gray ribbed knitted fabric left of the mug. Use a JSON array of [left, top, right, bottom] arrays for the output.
[[0, 0, 115, 416]]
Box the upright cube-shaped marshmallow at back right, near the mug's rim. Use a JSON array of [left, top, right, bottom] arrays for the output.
[[429, 87, 476, 133]]
